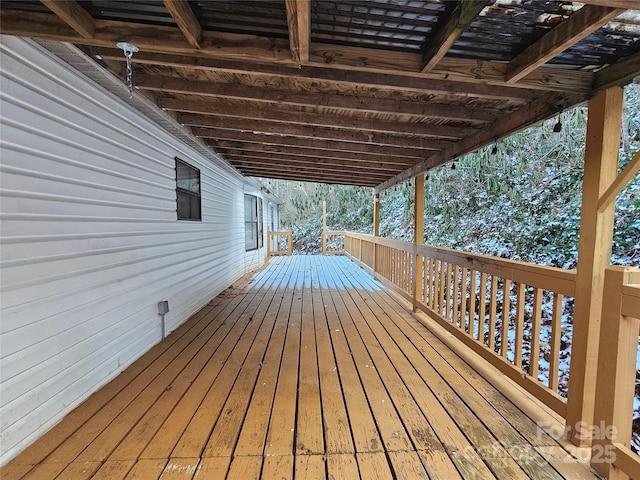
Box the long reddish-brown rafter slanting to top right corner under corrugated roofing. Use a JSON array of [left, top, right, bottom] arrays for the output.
[[506, 5, 625, 83]]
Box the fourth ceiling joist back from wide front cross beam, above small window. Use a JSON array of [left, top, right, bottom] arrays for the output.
[[180, 115, 468, 148]]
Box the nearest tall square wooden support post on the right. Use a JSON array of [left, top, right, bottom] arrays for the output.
[[566, 87, 623, 445]]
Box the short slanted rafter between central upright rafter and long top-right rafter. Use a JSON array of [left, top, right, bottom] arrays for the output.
[[421, 0, 489, 73]]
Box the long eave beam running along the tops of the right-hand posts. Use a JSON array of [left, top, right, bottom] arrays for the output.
[[376, 92, 582, 191]]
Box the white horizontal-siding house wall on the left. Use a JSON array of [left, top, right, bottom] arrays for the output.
[[0, 37, 267, 465]]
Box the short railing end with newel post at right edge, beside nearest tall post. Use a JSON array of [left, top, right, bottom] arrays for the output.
[[591, 267, 640, 480]]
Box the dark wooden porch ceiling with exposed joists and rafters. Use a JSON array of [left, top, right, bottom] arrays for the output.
[[0, 0, 640, 190]]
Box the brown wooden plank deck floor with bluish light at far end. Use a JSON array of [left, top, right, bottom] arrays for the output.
[[1, 256, 594, 480]]
